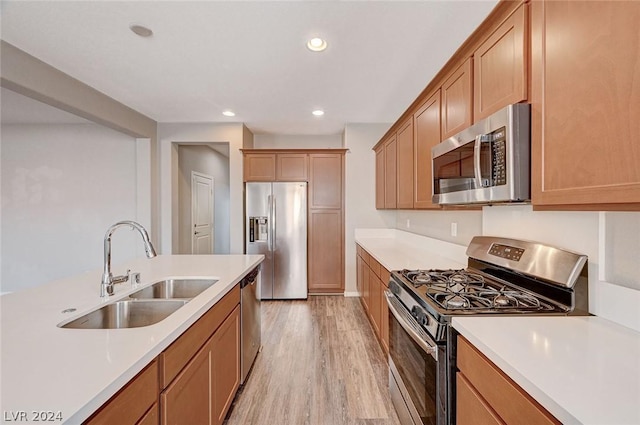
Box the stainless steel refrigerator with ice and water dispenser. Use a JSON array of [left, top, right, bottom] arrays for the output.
[[245, 182, 307, 300]]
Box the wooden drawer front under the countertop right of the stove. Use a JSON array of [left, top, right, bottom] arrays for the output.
[[457, 336, 560, 425]]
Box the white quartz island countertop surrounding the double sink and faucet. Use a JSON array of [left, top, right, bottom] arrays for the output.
[[0, 255, 264, 424]]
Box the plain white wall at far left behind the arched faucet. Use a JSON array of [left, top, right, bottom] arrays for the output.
[[0, 124, 144, 292]]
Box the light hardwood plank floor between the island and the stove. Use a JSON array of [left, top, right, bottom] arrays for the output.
[[225, 296, 399, 425]]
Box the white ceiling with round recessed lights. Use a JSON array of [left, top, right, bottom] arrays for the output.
[[1, 0, 497, 135]]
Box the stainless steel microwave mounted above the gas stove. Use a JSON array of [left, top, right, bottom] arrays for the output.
[[431, 103, 531, 205]]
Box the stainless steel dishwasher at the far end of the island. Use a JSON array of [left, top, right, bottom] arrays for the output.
[[240, 266, 262, 385]]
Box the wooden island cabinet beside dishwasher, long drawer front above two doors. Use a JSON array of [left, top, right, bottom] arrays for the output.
[[158, 286, 240, 425]]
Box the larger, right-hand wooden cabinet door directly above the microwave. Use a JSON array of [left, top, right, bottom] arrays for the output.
[[473, 4, 528, 121]]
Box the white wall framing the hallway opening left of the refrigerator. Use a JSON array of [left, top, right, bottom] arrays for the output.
[[158, 123, 254, 254]]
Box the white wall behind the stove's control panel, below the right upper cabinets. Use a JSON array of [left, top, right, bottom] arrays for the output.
[[482, 206, 640, 331]]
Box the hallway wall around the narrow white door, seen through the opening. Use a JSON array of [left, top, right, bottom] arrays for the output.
[[177, 145, 230, 254]]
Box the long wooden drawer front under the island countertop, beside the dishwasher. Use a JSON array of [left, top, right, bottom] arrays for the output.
[[159, 285, 240, 388]]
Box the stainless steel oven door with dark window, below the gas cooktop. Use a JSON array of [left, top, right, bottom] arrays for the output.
[[385, 291, 446, 425]]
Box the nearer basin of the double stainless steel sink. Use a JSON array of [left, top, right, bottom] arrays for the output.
[[59, 300, 187, 329]]
